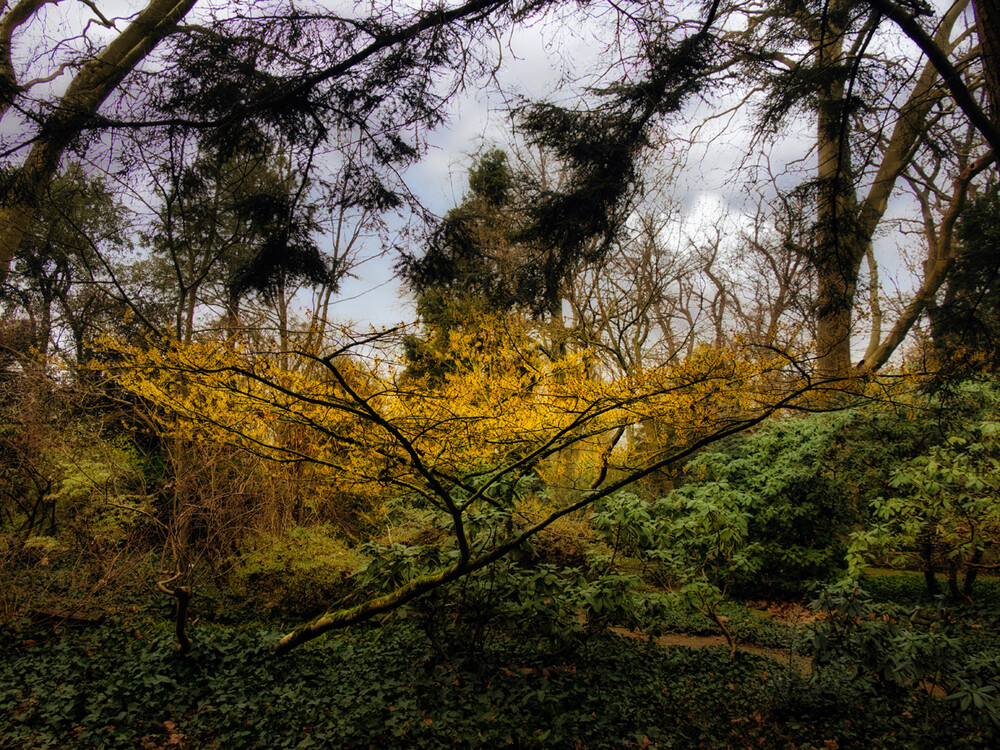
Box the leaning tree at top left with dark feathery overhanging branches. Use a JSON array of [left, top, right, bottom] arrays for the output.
[[0, 0, 584, 290]]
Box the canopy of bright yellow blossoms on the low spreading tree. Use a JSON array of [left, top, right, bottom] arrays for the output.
[[105, 324, 801, 512]]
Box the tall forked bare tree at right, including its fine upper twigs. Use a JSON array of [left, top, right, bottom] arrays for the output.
[[704, 0, 992, 379]]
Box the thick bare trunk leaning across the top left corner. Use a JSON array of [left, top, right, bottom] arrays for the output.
[[0, 0, 196, 282]]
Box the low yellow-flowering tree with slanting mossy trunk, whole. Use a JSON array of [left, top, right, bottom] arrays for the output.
[[108, 320, 810, 652]]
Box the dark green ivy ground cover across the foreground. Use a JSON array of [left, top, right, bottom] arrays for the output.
[[0, 626, 997, 750]]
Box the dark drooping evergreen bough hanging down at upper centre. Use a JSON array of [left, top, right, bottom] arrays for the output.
[[516, 30, 714, 312]]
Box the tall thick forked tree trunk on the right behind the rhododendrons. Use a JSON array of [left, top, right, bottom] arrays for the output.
[[736, 0, 981, 378]]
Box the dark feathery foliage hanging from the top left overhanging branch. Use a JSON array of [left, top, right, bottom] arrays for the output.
[[154, 0, 532, 223]]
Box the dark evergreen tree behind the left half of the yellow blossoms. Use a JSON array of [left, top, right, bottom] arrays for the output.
[[137, 134, 330, 340]]
